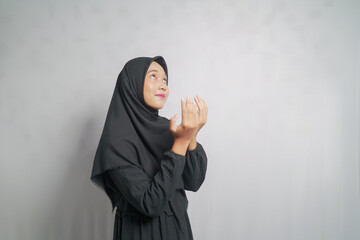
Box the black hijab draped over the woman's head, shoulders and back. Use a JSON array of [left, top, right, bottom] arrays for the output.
[[90, 56, 174, 210]]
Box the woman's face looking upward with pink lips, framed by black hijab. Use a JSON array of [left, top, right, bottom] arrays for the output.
[[144, 61, 169, 109]]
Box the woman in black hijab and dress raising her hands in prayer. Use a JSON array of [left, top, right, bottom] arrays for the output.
[[91, 56, 208, 240]]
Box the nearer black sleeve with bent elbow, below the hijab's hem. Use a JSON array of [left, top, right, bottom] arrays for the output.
[[108, 149, 185, 217]]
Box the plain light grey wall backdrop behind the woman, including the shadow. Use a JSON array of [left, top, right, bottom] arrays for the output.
[[0, 0, 360, 240]]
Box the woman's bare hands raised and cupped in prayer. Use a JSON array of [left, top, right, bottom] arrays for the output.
[[169, 95, 208, 142]]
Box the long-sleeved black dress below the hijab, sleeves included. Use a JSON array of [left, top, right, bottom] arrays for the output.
[[107, 143, 207, 240]]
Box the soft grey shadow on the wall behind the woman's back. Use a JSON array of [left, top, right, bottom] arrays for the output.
[[41, 114, 115, 240]]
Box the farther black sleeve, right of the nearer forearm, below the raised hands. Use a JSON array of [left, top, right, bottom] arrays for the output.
[[182, 142, 207, 192]]
